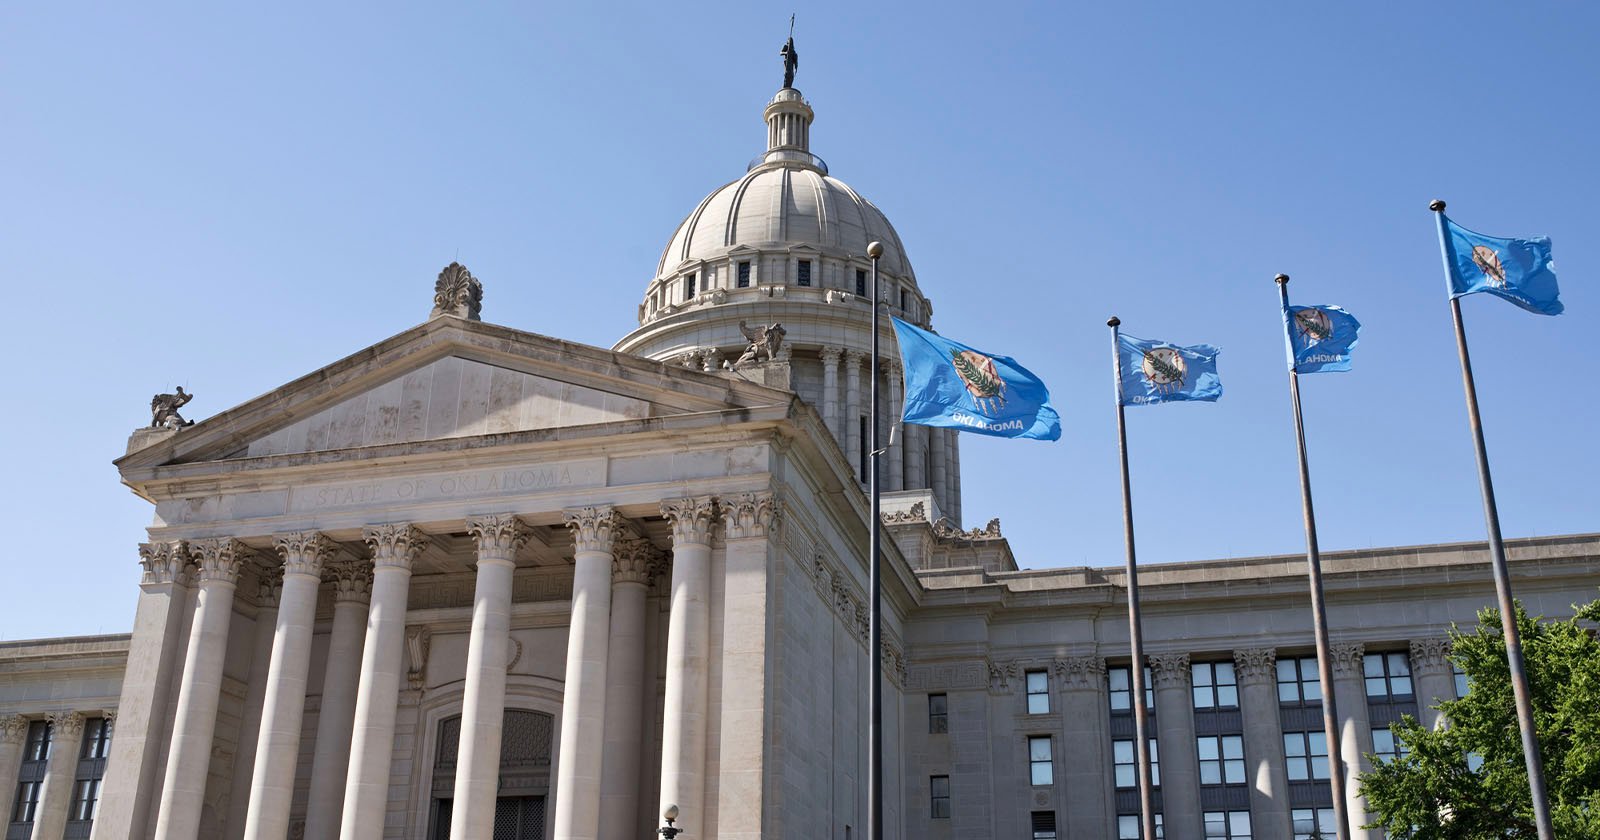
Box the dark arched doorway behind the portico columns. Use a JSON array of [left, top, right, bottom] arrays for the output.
[[427, 709, 555, 840]]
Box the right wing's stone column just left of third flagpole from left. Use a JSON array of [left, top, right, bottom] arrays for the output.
[[1234, 648, 1294, 837]]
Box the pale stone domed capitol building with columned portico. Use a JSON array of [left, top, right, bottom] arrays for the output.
[[0, 58, 1600, 840]]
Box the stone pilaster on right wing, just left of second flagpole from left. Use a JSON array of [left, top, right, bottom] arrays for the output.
[[1054, 656, 1115, 837]]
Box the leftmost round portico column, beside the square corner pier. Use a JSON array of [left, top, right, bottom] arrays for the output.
[[155, 539, 250, 840]]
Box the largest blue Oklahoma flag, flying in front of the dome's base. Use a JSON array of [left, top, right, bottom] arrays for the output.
[[891, 318, 1061, 440]]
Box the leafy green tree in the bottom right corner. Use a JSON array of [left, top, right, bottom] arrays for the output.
[[1362, 602, 1600, 840]]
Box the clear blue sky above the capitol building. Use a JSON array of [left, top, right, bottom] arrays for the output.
[[0, 2, 1600, 638]]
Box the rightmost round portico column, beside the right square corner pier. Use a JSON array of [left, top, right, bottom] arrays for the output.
[[661, 496, 716, 824]]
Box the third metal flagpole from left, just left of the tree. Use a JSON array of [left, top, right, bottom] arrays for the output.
[[1274, 274, 1350, 840]]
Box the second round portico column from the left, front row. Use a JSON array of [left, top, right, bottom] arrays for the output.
[[245, 531, 338, 840]]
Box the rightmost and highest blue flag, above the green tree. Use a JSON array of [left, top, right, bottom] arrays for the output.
[[1445, 219, 1566, 315]]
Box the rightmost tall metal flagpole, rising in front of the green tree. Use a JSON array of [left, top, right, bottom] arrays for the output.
[[1427, 198, 1555, 840]]
